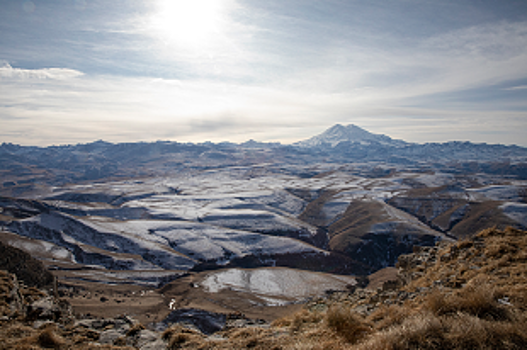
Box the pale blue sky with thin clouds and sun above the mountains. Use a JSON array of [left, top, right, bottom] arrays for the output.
[[0, 0, 527, 146]]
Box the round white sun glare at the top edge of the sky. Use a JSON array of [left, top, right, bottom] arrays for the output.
[[153, 0, 225, 47]]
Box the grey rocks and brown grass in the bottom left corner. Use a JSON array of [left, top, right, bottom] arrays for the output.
[[0, 270, 166, 350]]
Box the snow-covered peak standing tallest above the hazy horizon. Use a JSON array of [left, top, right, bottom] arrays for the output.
[[294, 124, 407, 147]]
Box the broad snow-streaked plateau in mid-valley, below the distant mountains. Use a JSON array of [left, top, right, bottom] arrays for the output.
[[121, 168, 414, 234]]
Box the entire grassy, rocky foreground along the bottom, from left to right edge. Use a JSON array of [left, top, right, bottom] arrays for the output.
[[0, 228, 527, 350]]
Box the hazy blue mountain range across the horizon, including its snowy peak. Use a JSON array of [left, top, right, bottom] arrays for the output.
[[0, 124, 527, 196]]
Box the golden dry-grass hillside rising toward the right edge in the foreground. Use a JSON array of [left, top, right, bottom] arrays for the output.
[[165, 228, 527, 350]]
